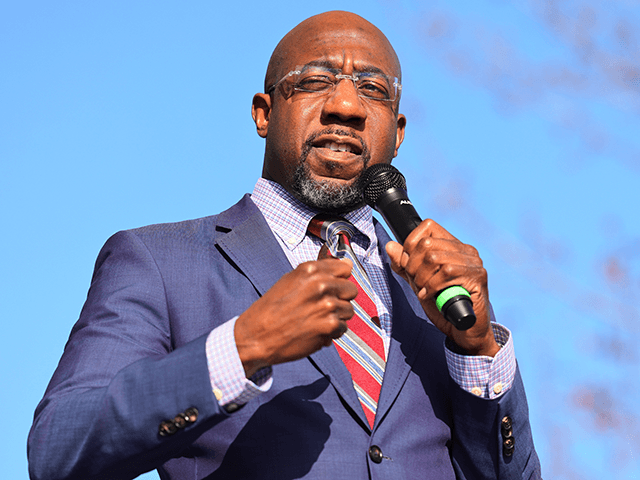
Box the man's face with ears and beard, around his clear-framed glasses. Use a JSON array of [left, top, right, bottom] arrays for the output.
[[253, 17, 405, 212]]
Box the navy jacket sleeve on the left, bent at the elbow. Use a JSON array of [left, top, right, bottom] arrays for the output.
[[28, 232, 228, 480]]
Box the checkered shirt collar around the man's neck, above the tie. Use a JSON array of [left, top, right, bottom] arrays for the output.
[[251, 178, 378, 256]]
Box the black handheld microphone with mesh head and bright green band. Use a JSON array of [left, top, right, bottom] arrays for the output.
[[360, 163, 476, 330]]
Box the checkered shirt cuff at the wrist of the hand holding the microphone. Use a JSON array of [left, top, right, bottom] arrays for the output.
[[444, 323, 516, 399]]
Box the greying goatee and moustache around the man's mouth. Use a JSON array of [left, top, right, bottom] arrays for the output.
[[291, 129, 371, 213]]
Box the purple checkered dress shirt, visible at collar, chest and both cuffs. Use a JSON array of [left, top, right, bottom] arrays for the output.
[[206, 178, 515, 405]]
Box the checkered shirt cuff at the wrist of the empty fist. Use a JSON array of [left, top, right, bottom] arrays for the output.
[[205, 317, 273, 413]]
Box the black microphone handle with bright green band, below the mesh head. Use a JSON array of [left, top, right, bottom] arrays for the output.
[[376, 188, 476, 330]]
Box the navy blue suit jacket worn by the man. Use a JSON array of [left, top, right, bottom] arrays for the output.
[[29, 196, 540, 480]]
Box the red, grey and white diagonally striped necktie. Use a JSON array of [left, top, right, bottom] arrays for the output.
[[308, 215, 386, 427]]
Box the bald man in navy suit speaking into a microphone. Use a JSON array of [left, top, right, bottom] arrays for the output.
[[29, 12, 539, 479]]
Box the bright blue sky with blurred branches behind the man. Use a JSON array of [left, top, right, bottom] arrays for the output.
[[0, 0, 640, 480]]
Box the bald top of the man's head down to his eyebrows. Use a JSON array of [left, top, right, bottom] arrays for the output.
[[264, 11, 402, 91]]
